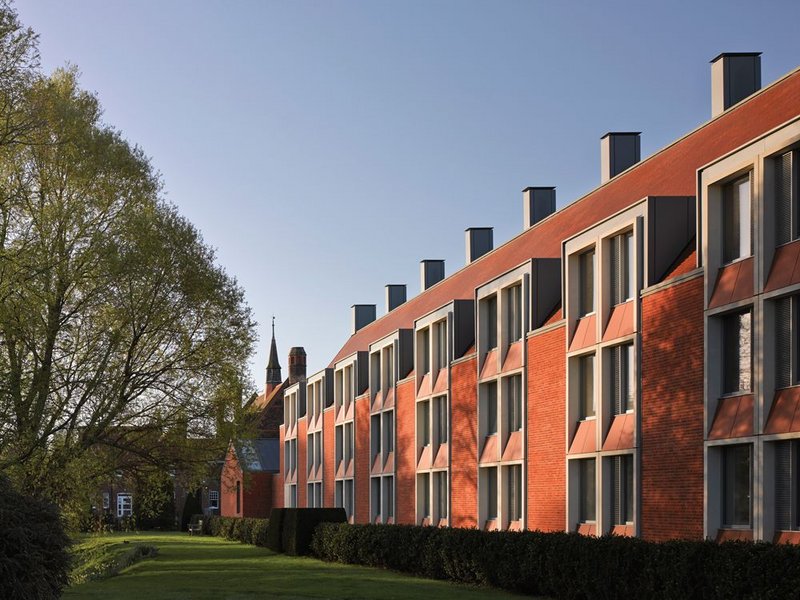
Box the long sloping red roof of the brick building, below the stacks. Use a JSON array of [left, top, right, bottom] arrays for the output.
[[329, 69, 800, 367]]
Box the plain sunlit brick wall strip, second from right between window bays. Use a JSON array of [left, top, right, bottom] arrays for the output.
[[527, 327, 567, 531]]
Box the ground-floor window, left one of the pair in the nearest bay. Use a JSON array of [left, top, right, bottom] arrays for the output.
[[722, 444, 753, 527]]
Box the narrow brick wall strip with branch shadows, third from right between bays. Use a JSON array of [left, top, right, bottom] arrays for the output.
[[450, 358, 478, 527]]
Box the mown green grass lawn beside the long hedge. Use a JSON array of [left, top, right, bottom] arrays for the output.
[[64, 532, 519, 600]]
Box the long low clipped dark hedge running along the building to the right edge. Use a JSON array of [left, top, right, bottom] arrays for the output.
[[311, 523, 800, 600]]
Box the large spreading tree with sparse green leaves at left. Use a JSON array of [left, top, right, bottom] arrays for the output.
[[0, 4, 254, 516]]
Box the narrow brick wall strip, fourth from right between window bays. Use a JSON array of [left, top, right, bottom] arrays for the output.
[[394, 378, 416, 525]]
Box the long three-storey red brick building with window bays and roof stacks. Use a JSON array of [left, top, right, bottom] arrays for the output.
[[272, 54, 800, 540]]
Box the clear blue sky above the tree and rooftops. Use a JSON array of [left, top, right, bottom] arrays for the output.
[[16, 0, 800, 385]]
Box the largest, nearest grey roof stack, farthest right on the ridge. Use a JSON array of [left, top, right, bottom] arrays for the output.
[[711, 52, 761, 118]]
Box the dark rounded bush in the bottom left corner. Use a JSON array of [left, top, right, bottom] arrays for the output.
[[0, 475, 69, 600]]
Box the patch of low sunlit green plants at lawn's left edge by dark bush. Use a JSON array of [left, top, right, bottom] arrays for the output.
[[69, 537, 158, 585]]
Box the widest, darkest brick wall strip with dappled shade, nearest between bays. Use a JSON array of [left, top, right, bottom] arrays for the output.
[[640, 278, 703, 541]]
